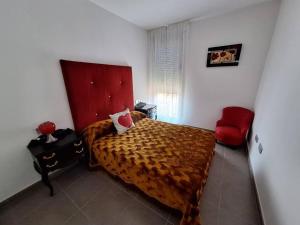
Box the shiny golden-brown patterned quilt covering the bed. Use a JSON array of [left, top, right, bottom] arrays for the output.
[[84, 112, 215, 225]]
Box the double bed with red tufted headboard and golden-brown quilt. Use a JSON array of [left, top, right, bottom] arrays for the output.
[[61, 60, 215, 225]]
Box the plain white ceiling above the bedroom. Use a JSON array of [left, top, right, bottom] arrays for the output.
[[90, 0, 271, 29]]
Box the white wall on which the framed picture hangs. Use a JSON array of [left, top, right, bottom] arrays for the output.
[[184, 1, 279, 129]]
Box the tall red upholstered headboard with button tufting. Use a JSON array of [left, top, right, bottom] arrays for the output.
[[60, 60, 133, 132]]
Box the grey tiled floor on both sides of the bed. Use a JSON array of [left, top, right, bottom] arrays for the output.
[[0, 145, 260, 225]]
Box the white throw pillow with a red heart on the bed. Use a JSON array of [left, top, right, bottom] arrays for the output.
[[109, 109, 134, 134]]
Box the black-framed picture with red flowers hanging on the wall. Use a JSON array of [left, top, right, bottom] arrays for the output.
[[206, 44, 242, 67]]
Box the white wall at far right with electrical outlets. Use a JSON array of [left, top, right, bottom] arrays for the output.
[[250, 0, 300, 225]]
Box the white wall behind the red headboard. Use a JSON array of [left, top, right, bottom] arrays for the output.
[[0, 0, 147, 202]]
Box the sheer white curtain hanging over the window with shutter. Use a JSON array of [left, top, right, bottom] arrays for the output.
[[148, 22, 189, 123]]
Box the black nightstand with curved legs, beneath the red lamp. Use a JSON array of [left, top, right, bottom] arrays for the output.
[[27, 129, 85, 196]]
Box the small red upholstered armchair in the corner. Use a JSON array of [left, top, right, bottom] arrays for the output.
[[215, 106, 254, 146]]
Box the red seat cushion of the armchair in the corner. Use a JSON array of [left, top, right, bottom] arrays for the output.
[[215, 126, 243, 145]]
